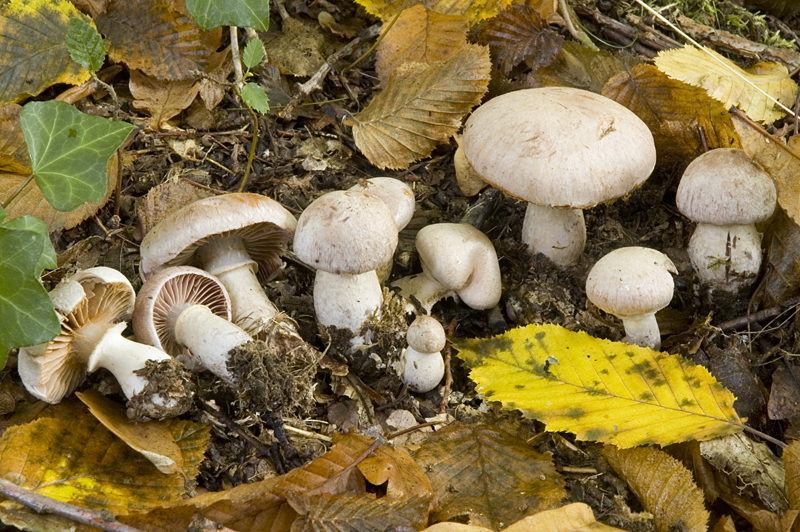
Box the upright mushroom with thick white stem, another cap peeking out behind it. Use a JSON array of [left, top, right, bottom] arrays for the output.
[[294, 191, 397, 333]]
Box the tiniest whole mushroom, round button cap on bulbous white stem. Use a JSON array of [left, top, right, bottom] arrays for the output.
[[401, 316, 446, 393]]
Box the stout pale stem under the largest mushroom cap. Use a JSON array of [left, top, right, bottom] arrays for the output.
[[522, 203, 586, 266]]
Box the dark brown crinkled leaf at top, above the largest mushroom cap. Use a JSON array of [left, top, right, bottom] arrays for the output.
[[480, 5, 564, 75]]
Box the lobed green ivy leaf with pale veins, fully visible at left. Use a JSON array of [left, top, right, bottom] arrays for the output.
[[19, 100, 134, 211]]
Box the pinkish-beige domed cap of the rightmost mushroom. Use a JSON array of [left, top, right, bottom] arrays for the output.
[[675, 148, 777, 225]]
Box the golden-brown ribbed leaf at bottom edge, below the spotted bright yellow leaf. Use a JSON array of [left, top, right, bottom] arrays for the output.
[[603, 445, 708, 532]]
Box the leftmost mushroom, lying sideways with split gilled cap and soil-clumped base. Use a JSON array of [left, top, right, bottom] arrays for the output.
[[18, 267, 194, 419]]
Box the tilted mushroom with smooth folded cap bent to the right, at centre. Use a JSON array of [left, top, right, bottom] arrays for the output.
[[392, 223, 503, 313]]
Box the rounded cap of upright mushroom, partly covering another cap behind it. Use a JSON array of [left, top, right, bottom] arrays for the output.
[[293, 190, 397, 275]]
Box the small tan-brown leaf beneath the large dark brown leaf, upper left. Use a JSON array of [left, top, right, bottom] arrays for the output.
[[128, 70, 200, 131]]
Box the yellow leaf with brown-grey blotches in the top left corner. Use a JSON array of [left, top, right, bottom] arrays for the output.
[[0, 0, 89, 103]]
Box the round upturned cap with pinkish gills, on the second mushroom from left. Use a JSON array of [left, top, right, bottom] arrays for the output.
[[133, 266, 231, 360]]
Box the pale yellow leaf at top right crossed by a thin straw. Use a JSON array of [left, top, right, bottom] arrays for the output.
[[656, 46, 797, 123]]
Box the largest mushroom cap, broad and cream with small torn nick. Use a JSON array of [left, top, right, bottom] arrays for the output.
[[462, 87, 656, 209]]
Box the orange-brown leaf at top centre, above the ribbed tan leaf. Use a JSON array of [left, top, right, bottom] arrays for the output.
[[375, 4, 469, 88]]
